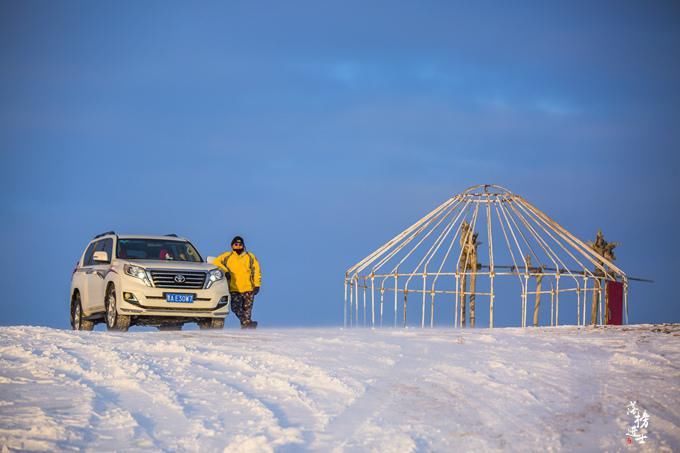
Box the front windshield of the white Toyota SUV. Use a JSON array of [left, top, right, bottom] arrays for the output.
[[116, 239, 203, 263]]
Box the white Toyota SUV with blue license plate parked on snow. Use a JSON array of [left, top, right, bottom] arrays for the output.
[[71, 231, 230, 331]]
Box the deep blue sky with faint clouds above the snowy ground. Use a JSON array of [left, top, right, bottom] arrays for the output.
[[0, 1, 680, 327]]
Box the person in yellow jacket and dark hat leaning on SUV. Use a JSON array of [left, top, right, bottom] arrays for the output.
[[213, 236, 262, 329]]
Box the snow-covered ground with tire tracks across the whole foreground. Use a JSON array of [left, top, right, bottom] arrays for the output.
[[0, 325, 680, 452]]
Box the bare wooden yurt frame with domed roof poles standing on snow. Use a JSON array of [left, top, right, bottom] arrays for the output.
[[344, 184, 628, 327]]
